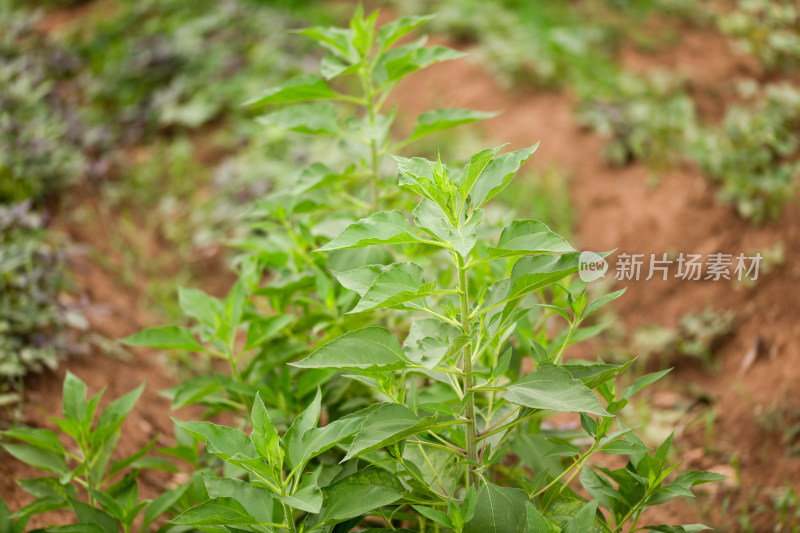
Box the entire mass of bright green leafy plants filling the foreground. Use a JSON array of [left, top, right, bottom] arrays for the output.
[[0, 10, 721, 533]]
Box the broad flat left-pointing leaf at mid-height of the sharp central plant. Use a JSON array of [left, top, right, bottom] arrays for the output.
[[290, 326, 410, 372]]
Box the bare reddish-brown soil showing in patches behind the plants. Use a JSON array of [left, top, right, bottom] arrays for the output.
[[0, 3, 800, 532]]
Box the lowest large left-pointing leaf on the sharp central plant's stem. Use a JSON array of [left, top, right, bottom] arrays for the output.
[[342, 404, 437, 461]]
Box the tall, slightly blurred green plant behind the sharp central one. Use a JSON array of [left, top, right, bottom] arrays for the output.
[[122, 11, 491, 418]]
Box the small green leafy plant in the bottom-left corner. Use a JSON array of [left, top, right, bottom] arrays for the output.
[[0, 372, 190, 533]]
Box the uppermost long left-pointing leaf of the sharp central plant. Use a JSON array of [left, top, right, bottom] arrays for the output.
[[318, 211, 423, 251]]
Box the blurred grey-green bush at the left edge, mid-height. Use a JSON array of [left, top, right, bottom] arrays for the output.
[[0, 202, 83, 405]]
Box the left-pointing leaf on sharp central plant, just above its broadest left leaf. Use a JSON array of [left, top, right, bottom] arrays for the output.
[[349, 263, 436, 313]]
